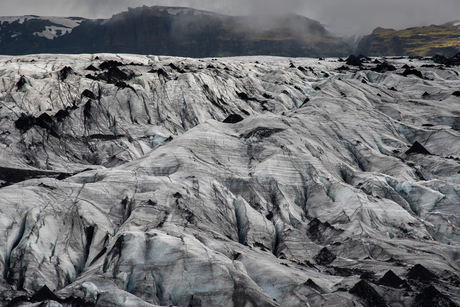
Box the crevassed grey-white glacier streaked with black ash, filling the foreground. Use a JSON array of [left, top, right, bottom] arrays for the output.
[[0, 54, 460, 307]]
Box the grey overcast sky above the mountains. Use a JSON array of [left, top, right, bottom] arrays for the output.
[[0, 0, 460, 35]]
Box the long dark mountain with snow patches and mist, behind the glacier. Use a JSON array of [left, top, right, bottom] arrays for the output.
[[0, 6, 352, 57]]
